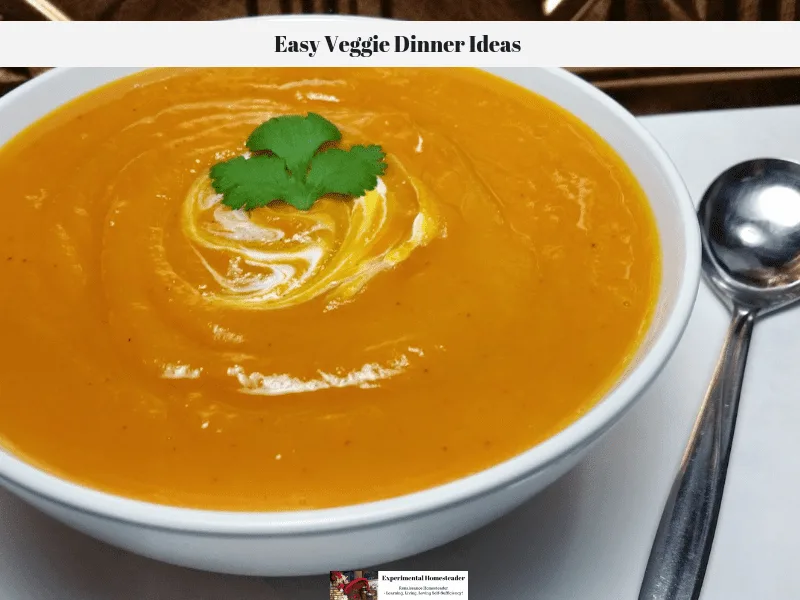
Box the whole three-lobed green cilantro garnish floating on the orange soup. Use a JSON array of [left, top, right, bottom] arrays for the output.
[[210, 113, 387, 210]]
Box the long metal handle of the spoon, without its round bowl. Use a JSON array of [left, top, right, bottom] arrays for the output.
[[639, 308, 756, 600]]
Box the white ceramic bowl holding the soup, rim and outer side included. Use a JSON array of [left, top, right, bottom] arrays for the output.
[[0, 68, 700, 575]]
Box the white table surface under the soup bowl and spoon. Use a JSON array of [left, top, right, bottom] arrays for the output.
[[0, 106, 800, 600]]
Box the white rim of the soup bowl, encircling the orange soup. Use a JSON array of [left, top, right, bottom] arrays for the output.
[[0, 64, 701, 537]]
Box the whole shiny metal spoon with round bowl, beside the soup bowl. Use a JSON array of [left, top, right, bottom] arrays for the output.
[[639, 159, 800, 600]]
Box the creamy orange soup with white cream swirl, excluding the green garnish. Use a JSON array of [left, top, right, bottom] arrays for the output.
[[0, 68, 660, 510]]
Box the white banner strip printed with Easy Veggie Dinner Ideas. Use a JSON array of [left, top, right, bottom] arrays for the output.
[[0, 16, 800, 67]]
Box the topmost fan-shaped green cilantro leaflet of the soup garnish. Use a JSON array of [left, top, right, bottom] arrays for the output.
[[247, 113, 342, 178]]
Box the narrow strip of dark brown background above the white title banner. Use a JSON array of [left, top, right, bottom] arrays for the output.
[[0, 0, 800, 21]]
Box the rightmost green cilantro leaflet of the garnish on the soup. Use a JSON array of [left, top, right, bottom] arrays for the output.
[[306, 146, 386, 196]]
